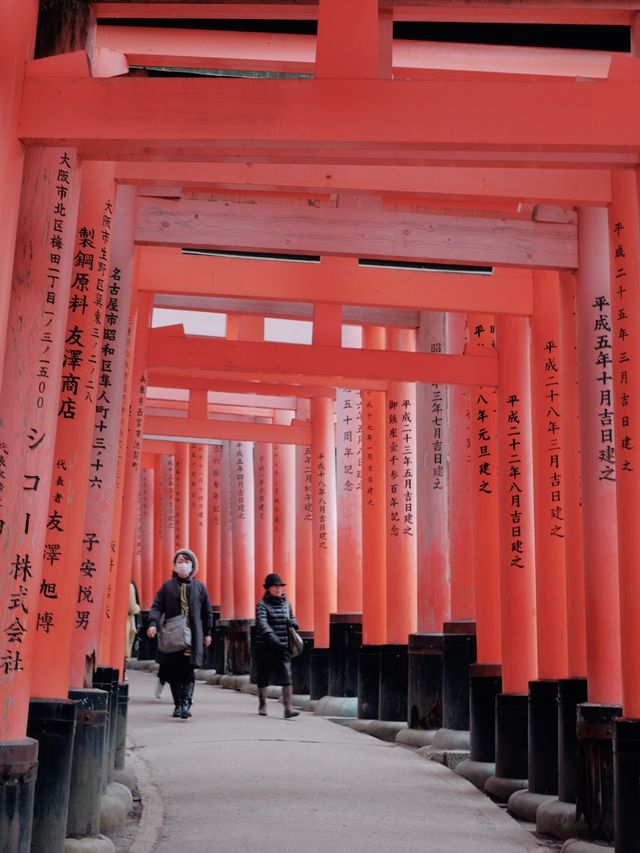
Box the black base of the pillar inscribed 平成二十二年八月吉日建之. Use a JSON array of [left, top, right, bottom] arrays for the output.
[[496, 693, 529, 779]]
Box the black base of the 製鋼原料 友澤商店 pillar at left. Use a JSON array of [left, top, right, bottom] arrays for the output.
[[26, 699, 76, 853]]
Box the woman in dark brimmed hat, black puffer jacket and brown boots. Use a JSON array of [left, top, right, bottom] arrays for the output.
[[256, 573, 299, 719]]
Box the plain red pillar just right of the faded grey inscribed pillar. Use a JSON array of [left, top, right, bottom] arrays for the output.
[[445, 313, 476, 629]]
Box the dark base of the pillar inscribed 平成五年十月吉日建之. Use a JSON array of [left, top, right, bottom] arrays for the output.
[[576, 702, 620, 841]]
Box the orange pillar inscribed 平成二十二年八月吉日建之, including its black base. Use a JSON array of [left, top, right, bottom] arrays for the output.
[[496, 316, 537, 779]]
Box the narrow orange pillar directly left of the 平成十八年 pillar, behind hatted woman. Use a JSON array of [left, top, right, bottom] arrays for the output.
[[294, 430, 314, 631]]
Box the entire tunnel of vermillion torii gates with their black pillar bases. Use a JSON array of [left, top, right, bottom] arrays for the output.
[[0, 0, 640, 851]]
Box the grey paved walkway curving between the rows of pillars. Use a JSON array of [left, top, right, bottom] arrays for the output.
[[127, 671, 552, 853]]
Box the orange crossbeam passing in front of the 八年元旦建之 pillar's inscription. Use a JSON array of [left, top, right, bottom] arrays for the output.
[[147, 329, 498, 388]]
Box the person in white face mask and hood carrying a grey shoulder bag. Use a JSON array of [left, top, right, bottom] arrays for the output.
[[147, 548, 212, 720]]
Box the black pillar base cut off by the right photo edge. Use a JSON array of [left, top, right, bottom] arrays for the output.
[[613, 718, 640, 853]]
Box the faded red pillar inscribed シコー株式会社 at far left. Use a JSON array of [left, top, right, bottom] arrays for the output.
[[0, 149, 78, 742]]
